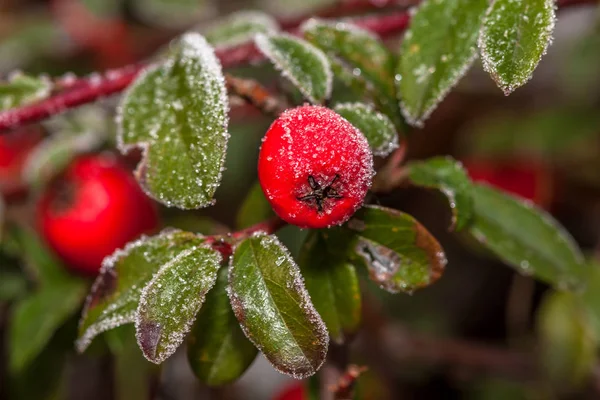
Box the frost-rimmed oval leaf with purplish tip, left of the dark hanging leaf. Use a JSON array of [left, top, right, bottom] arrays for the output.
[[135, 245, 223, 364]]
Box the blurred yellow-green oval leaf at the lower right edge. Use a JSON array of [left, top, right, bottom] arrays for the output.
[[537, 292, 598, 390]]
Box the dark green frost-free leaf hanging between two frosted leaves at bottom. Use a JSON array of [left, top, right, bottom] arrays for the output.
[[187, 268, 258, 386]]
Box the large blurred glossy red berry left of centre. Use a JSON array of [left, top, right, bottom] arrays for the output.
[[37, 155, 158, 274]]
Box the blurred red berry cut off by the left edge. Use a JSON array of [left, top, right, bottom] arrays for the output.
[[0, 127, 44, 197]]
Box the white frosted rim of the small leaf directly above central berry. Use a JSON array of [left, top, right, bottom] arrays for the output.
[[254, 33, 333, 104]]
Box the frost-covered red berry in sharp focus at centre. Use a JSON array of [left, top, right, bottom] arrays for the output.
[[258, 106, 373, 228]]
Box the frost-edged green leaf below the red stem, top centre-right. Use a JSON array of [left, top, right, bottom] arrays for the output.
[[300, 19, 402, 126]]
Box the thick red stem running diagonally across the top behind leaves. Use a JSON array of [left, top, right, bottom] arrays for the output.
[[0, 0, 598, 132]]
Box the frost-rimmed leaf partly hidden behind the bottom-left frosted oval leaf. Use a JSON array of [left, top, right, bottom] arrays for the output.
[[75, 229, 203, 353]]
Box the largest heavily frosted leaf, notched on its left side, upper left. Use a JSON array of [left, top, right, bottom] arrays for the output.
[[116, 33, 229, 209]]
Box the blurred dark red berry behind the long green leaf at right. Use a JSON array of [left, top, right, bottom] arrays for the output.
[[463, 159, 552, 207]]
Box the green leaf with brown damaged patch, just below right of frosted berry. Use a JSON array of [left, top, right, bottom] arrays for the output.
[[346, 206, 446, 293]]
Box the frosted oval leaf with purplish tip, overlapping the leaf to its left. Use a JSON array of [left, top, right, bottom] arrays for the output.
[[135, 245, 221, 364]]
